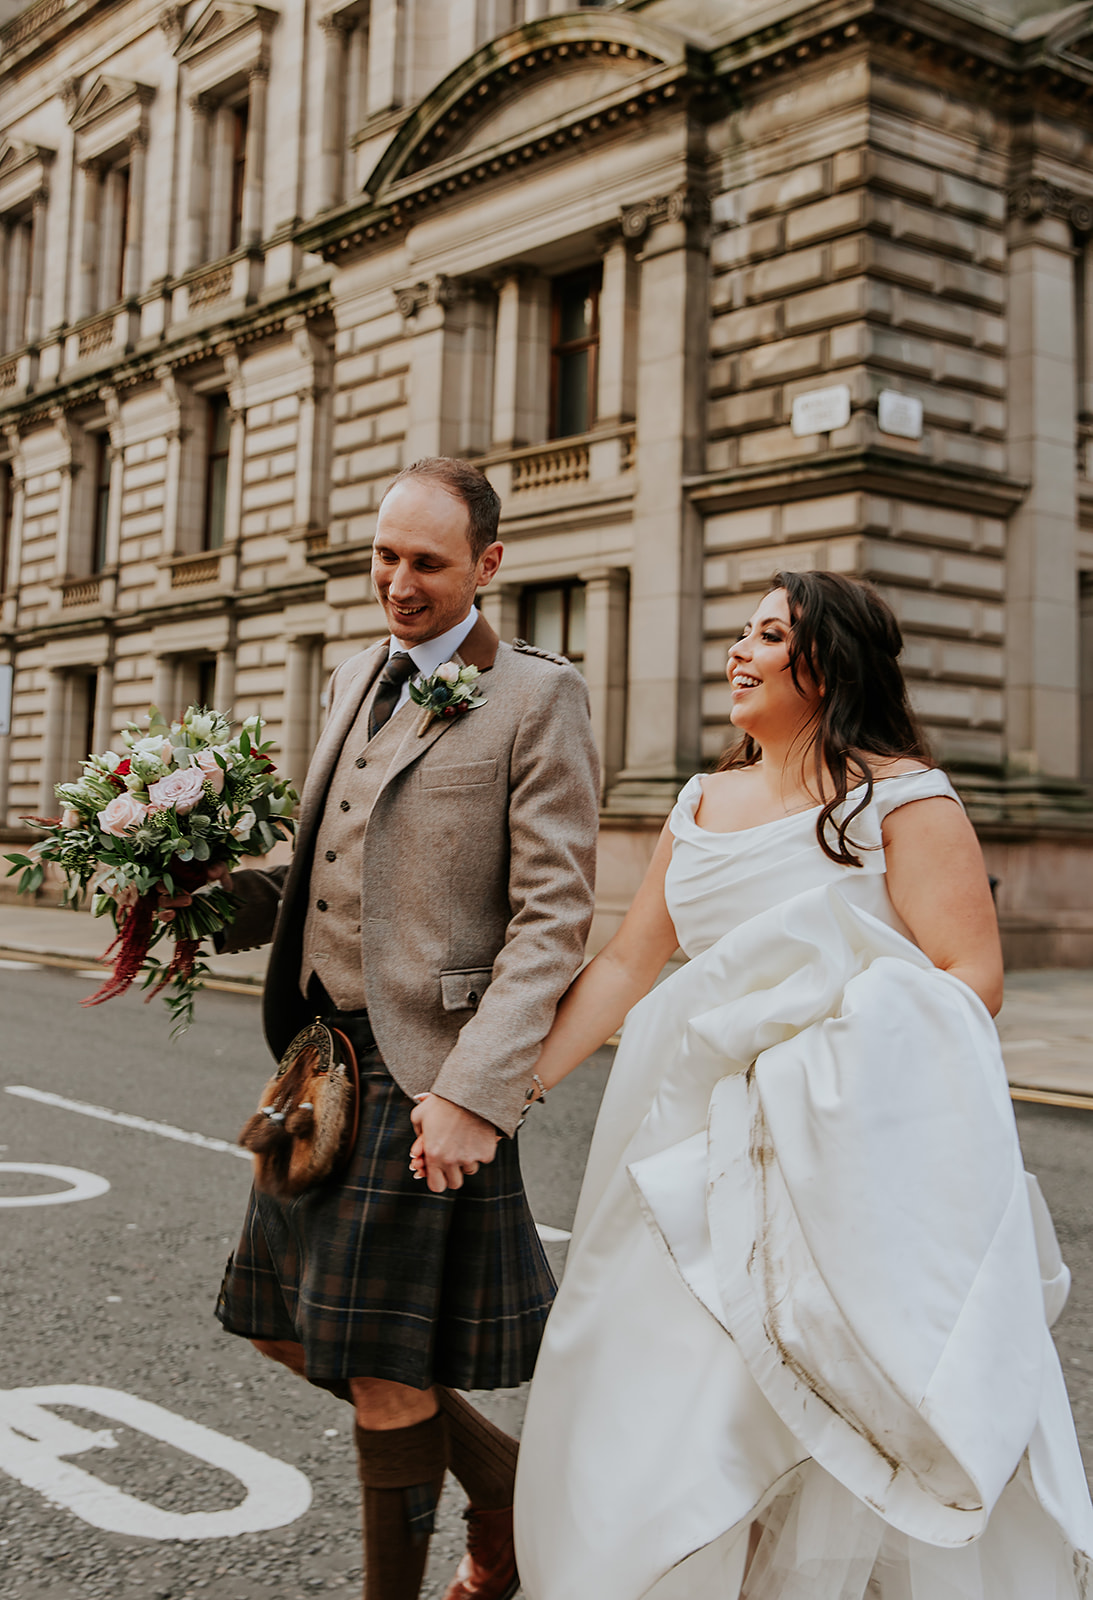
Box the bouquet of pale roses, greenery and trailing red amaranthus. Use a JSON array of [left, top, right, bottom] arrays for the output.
[[6, 706, 298, 1034]]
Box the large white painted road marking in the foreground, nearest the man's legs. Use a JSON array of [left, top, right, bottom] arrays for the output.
[[0, 1384, 310, 1539]]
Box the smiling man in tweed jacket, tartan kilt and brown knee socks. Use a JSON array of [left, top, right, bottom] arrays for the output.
[[208, 458, 597, 1600]]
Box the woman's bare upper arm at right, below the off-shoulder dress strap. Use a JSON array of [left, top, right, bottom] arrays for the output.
[[883, 797, 1002, 1016]]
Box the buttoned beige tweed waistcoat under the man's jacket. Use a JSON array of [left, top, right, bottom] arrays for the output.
[[299, 680, 421, 1011]]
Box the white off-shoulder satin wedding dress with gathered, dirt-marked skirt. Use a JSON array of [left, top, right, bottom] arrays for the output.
[[517, 771, 1093, 1600]]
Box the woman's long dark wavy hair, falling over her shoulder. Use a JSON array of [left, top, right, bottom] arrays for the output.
[[717, 573, 933, 867]]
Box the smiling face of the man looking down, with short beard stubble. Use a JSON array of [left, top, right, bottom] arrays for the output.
[[371, 478, 501, 646]]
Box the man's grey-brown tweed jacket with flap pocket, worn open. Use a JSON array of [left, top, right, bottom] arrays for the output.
[[224, 618, 599, 1134]]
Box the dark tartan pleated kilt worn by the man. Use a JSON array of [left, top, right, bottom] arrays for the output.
[[216, 1013, 555, 1389]]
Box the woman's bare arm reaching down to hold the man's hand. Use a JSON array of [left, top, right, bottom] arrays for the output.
[[534, 824, 679, 1090]]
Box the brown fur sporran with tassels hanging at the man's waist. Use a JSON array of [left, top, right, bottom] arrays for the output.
[[238, 1021, 360, 1200]]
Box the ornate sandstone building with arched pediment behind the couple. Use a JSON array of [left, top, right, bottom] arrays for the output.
[[0, 0, 1093, 963]]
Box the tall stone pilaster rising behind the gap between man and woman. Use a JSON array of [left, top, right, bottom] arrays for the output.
[[608, 189, 707, 816]]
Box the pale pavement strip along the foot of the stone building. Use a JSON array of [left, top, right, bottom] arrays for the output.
[[0, 902, 1093, 1109]]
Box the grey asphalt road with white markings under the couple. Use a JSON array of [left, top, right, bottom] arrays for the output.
[[0, 963, 1093, 1600]]
